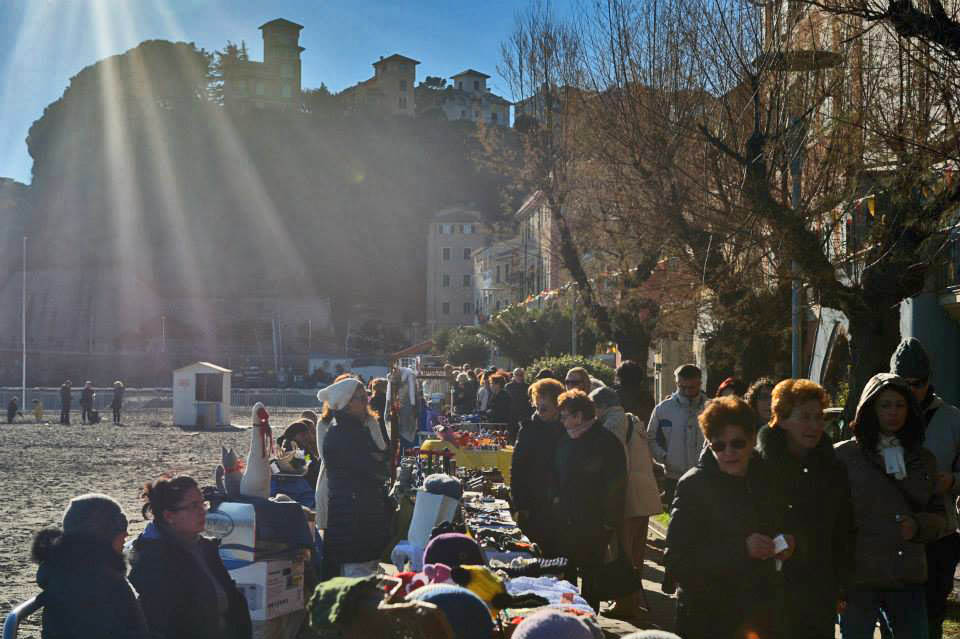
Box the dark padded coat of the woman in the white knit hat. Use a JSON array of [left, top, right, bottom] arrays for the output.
[[323, 411, 390, 564]]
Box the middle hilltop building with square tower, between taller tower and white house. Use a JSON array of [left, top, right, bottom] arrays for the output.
[[337, 53, 420, 115]]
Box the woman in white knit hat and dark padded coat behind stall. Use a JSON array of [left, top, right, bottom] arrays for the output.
[[318, 379, 391, 577]]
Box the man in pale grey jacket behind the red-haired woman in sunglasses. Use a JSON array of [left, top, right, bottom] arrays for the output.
[[647, 364, 707, 508]]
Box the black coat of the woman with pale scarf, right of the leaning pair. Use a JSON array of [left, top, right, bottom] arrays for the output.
[[547, 422, 627, 566]]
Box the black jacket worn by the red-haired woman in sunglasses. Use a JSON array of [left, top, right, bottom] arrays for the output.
[[664, 449, 789, 639]]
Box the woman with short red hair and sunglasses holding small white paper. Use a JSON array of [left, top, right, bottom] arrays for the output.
[[664, 397, 793, 639]]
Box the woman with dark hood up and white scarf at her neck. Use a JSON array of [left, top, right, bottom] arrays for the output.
[[836, 373, 946, 639]]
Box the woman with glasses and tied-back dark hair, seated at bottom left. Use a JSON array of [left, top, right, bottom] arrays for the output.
[[130, 476, 252, 639]]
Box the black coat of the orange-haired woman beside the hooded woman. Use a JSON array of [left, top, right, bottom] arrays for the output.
[[759, 426, 855, 628]]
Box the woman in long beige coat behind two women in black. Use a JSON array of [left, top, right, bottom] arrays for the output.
[[590, 387, 663, 618]]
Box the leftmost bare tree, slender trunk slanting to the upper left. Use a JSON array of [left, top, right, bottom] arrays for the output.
[[492, 2, 659, 370]]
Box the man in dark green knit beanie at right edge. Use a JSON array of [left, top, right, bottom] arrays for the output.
[[890, 337, 960, 639]]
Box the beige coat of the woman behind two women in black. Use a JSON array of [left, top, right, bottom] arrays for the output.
[[600, 406, 663, 518]]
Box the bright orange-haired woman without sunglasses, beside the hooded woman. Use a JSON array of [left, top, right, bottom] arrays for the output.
[[758, 379, 854, 639]]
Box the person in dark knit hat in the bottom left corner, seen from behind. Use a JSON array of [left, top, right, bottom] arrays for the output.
[[32, 494, 150, 639]]
